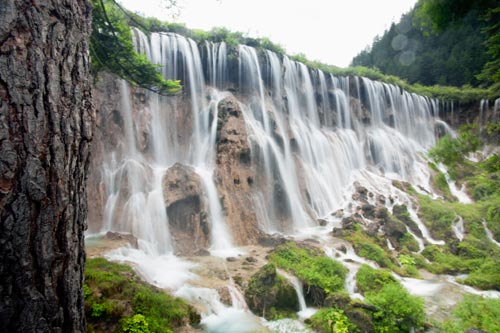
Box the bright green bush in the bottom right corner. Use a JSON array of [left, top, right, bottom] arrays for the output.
[[440, 295, 500, 333]]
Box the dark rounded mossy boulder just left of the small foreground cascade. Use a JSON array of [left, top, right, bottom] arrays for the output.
[[245, 264, 299, 320]]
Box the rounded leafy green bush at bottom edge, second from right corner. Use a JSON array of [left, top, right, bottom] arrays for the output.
[[366, 283, 425, 333]]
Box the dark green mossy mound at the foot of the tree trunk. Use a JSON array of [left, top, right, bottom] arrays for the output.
[[84, 258, 200, 332]]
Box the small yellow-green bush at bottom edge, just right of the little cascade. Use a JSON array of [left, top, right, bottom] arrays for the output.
[[310, 308, 357, 333]]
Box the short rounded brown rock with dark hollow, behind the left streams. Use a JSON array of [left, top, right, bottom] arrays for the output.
[[162, 163, 210, 255]]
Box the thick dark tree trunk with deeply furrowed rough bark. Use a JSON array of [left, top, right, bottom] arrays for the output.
[[0, 0, 93, 332]]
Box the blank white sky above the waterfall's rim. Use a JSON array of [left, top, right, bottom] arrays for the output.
[[119, 0, 417, 67]]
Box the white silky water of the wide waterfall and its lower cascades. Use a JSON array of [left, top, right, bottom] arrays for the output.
[[91, 30, 498, 332]]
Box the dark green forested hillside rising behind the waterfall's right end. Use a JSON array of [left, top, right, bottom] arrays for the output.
[[352, 0, 499, 86]]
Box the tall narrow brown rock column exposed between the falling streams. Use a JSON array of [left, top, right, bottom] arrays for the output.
[[215, 96, 259, 244]]
